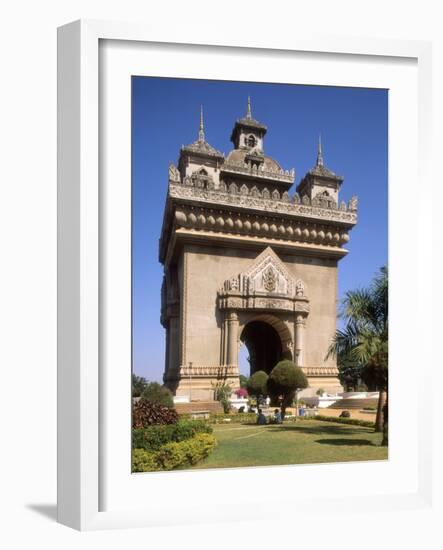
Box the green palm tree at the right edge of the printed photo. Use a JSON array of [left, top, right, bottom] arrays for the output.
[[327, 266, 388, 445]]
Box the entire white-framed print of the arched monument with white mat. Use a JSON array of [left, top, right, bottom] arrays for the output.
[[58, 21, 432, 529]]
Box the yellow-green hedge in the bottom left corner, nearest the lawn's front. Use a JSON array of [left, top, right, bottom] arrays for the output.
[[132, 433, 217, 472]]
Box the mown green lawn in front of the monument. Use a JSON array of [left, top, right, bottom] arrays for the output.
[[193, 420, 388, 468]]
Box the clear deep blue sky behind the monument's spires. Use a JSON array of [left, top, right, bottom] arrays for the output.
[[132, 77, 388, 382]]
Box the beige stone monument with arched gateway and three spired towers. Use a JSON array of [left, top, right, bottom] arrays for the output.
[[159, 100, 357, 401]]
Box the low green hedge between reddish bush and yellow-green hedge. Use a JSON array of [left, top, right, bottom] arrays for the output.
[[132, 420, 212, 451]]
